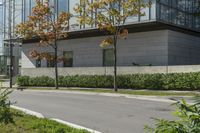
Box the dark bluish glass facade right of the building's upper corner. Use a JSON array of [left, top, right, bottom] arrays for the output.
[[157, 0, 200, 31]]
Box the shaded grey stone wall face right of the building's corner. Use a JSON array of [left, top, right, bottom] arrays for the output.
[[168, 30, 200, 65]]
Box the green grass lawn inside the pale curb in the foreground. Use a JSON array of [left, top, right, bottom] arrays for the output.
[[0, 110, 89, 133]]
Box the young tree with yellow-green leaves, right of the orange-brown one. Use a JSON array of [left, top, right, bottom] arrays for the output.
[[74, 0, 151, 91]]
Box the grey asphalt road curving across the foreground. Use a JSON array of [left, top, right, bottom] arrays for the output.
[[10, 91, 173, 133]]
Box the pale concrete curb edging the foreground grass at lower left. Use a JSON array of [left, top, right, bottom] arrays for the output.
[[10, 105, 102, 133]]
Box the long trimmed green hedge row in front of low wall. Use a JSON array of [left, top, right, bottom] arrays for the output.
[[17, 73, 200, 90]]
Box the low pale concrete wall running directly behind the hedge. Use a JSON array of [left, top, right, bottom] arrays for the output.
[[21, 65, 200, 77]]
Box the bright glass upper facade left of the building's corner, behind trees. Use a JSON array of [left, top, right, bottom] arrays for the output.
[[3, 0, 159, 38]]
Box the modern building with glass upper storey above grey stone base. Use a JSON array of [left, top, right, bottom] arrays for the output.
[[0, 0, 200, 75]]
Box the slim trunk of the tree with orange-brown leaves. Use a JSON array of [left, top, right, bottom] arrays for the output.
[[54, 41, 58, 89]]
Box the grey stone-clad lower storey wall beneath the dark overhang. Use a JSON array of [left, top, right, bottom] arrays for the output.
[[22, 30, 200, 68]]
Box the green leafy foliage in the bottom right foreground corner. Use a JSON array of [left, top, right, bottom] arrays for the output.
[[145, 97, 200, 133]]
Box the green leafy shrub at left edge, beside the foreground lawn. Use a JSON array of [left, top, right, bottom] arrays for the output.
[[0, 89, 14, 125]]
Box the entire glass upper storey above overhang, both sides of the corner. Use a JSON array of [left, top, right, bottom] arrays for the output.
[[0, 0, 200, 38]]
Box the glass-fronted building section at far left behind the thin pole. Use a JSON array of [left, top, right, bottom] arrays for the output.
[[0, 0, 22, 76]]
